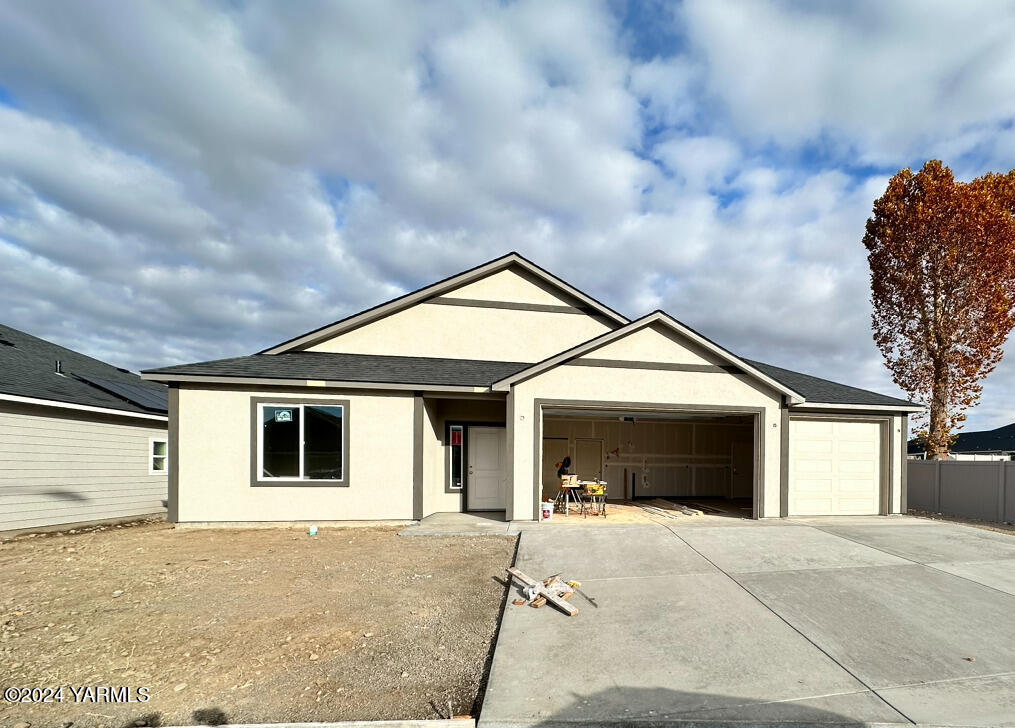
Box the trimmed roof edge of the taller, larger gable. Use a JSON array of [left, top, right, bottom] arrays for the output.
[[258, 252, 628, 354]]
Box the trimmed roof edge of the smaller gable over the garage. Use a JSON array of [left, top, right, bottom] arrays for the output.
[[492, 311, 805, 403]]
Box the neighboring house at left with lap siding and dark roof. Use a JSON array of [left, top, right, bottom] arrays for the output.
[[0, 325, 170, 531]]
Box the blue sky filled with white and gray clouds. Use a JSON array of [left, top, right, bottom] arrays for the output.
[[0, 0, 1015, 428]]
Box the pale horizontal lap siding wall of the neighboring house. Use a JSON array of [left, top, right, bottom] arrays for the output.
[[0, 403, 167, 531]]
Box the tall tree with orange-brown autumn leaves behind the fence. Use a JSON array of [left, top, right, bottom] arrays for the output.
[[864, 160, 1015, 459]]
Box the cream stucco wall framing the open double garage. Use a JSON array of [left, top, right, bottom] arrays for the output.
[[508, 365, 782, 520]]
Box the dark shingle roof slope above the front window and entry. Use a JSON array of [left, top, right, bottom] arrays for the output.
[[144, 351, 532, 387]]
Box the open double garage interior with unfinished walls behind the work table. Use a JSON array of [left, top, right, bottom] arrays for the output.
[[542, 407, 758, 518]]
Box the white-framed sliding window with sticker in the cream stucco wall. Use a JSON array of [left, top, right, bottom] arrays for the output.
[[257, 404, 345, 482]]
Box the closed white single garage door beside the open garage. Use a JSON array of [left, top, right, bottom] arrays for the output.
[[789, 419, 881, 516]]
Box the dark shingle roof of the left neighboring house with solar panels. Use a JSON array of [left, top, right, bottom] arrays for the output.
[[0, 324, 168, 415]]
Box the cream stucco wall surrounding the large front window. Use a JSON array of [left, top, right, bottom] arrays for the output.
[[178, 388, 414, 523]]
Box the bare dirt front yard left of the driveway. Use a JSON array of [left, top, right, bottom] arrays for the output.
[[0, 523, 515, 728]]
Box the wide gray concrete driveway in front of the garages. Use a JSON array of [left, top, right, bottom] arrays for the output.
[[480, 517, 1015, 728]]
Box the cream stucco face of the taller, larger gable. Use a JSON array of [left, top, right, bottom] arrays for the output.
[[308, 270, 612, 362]]
